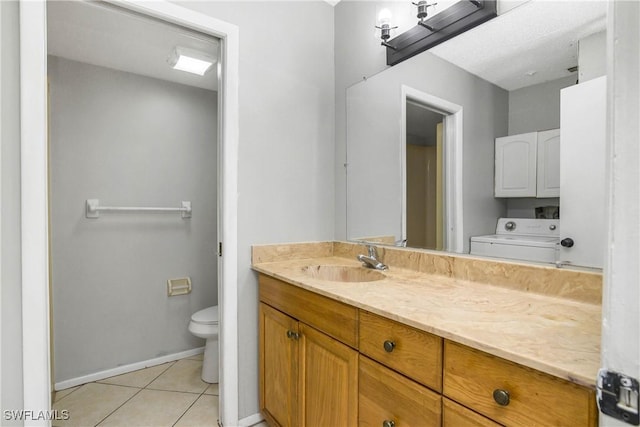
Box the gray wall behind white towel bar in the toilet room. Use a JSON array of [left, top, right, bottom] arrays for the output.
[[48, 56, 218, 382]]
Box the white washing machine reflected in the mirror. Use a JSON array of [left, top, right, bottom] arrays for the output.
[[470, 218, 560, 263]]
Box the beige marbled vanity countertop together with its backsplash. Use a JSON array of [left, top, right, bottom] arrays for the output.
[[253, 242, 602, 388]]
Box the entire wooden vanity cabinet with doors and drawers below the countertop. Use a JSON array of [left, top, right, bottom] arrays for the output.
[[259, 275, 598, 427]]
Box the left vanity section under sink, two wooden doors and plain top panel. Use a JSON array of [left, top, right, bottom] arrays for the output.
[[259, 276, 358, 427]]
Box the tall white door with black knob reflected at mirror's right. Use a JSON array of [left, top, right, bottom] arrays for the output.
[[559, 77, 607, 268]]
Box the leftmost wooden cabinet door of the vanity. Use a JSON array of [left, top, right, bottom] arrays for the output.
[[259, 303, 299, 427]]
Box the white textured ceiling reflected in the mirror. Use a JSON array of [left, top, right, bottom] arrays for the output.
[[429, 0, 608, 91]]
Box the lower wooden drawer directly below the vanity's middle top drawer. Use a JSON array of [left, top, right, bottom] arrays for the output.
[[358, 355, 441, 427]]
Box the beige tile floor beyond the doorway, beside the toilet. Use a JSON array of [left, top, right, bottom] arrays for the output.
[[53, 355, 218, 427]]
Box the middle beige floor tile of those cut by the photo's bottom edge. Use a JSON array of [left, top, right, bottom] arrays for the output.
[[100, 390, 198, 427]]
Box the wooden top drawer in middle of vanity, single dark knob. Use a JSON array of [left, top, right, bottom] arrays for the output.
[[359, 310, 442, 391]]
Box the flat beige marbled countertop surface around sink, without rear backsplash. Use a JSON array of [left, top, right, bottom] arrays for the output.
[[253, 242, 601, 388]]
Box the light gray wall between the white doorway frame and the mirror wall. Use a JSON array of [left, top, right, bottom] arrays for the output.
[[180, 1, 335, 417]]
